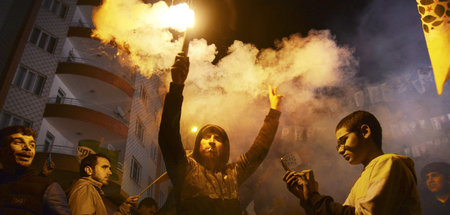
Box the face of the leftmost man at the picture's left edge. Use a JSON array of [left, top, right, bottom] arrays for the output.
[[1, 133, 36, 168]]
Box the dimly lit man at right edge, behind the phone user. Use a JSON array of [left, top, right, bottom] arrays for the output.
[[420, 162, 450, 215]]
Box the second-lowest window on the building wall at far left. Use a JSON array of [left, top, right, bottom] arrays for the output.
[[13, 66, 46, 95]]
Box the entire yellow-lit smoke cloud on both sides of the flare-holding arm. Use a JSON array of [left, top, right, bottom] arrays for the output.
[[93, 0, 356, 156]]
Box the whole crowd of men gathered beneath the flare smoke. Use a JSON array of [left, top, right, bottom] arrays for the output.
[[0, 53, 450, 215]]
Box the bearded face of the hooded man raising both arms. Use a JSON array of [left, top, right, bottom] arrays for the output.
[[199, 132, 223, 161]]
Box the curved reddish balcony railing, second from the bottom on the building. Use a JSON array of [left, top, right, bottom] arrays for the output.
[[60, 56, 135, 84]]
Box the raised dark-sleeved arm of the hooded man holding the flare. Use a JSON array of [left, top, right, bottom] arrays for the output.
[[158, 53, 189, 186]]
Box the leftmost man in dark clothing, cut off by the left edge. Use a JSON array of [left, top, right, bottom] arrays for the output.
[[0, 126, 70, 214]]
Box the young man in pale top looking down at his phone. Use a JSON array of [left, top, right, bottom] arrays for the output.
[[283, 111, 420, 215]]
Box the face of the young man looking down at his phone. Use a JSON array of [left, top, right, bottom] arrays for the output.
[[336, 127, 368, 165]]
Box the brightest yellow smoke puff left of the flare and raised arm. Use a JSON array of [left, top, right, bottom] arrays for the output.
[[92, 0, 193, 74]]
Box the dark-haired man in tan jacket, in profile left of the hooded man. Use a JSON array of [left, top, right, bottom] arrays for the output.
[[69, 154, 139, 215]]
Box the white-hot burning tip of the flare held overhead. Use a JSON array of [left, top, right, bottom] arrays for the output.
[[161, 3, 194, 31]]
